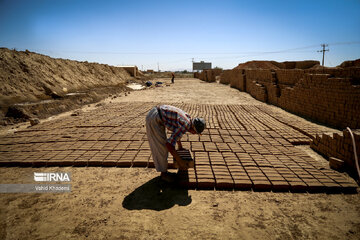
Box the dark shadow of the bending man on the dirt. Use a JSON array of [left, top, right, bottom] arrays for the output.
[[122, 177, 192, 211]]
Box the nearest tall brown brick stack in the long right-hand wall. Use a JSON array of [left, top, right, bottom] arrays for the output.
[[278, 74, 360, 129]]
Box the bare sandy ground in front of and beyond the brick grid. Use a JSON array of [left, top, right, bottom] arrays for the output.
[[0, 79, 360, 239]]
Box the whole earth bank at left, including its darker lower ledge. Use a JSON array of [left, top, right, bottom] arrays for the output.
[[0, 48, 155, 126]]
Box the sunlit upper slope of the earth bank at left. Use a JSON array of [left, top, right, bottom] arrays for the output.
[[0, 48, 131, 106]]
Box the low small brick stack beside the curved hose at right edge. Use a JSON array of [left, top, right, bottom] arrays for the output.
[[310, 130, 360, 172]]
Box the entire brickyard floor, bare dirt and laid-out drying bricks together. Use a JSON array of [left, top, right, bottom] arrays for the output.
[[0, 79, 360, 239]]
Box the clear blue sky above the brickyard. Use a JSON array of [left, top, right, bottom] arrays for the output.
[[0, 0, 360, 71]]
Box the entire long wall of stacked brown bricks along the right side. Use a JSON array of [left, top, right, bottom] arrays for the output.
[[195, 67, 360, 129]]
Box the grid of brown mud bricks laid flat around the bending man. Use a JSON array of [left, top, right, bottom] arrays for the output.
[[0, 103, 357, 192]]
